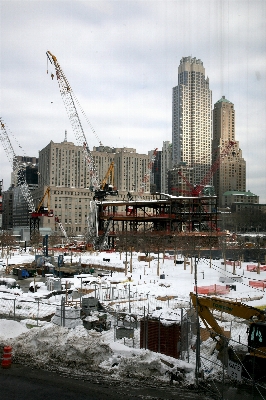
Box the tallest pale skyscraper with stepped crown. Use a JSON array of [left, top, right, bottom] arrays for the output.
[[172, 57, 212, 185]]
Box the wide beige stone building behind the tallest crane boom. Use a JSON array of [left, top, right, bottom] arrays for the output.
[[33, 140, 152, 236]]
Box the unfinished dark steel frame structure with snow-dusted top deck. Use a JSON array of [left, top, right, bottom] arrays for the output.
[[97, 195, 219, 247]]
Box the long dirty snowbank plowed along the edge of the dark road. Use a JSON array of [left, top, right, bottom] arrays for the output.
[[0, 320, 195, 384]]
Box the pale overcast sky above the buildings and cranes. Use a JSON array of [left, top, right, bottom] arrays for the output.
[[0, 0, 266, 203]]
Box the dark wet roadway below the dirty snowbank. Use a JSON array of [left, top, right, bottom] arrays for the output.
[[0, 364, 213, 400]]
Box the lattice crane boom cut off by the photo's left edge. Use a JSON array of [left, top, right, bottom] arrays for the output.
[[0, 118, 35, 212]]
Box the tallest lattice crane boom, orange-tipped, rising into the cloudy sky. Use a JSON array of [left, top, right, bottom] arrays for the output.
[[46, 51, 100, 191]]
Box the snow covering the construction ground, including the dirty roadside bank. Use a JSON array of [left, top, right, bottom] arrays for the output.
[[0, 248, 266, 384]]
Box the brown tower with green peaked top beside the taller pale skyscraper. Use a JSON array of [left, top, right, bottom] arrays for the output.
[[212, 96, 246, 207]]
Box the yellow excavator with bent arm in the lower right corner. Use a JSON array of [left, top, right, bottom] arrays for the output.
[[190, 292, 266, 379]]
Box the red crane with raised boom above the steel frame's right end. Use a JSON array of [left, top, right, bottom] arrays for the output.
[[172, 141, 236, 197]]
